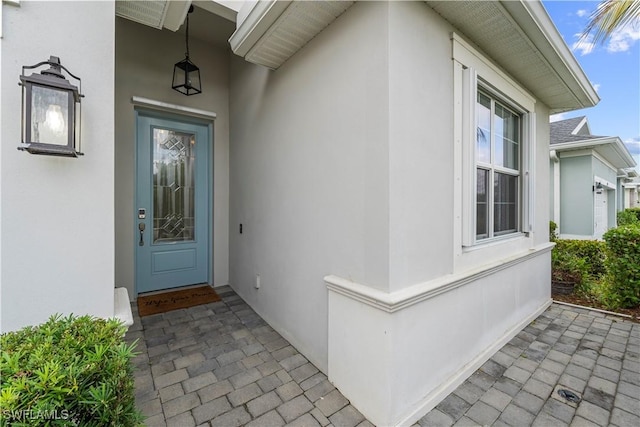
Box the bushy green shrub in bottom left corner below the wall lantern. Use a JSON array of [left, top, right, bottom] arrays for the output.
[[0, 315, 142, 426]]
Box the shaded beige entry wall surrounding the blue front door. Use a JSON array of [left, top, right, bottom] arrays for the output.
[[115, 15, 232, 299]]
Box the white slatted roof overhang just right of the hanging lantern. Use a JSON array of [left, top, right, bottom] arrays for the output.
[[229, 0, 353, 69]]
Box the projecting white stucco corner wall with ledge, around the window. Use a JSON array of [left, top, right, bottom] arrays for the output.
[[230, 2, 551, 425]]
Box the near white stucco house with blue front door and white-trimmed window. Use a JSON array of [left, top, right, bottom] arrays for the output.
[[0, 1, 600, 425]]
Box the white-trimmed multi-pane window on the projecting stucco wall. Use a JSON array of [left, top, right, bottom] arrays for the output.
[[452, 34, 535, 247]]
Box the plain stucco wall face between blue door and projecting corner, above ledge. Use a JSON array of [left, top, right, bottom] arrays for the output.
[[230, 2, 389, 370]]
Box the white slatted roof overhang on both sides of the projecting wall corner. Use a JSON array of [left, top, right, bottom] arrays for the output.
[[229, 0, 600, 113]]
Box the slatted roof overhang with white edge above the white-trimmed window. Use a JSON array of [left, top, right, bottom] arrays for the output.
[[426, 0, 600, 113]]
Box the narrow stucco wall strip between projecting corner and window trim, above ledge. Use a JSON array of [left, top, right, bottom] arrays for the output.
[[387, 2, 454, 291]]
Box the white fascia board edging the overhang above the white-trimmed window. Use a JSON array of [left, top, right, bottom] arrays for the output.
[[501, 0, 600, 113]]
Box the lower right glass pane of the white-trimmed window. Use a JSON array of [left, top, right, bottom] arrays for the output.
[[493, 172, 518, 235]]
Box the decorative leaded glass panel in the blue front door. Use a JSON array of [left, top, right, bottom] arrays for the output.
[[153, 128, 196, 244]]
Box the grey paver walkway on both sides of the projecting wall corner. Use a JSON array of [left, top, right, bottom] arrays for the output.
[[127, 286, 640, 427]]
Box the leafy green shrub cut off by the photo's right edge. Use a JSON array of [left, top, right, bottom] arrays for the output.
[[604, 224, 640, 307]]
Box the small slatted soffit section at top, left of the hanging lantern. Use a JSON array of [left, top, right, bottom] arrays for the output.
[[116, 0, 191, 31]]
